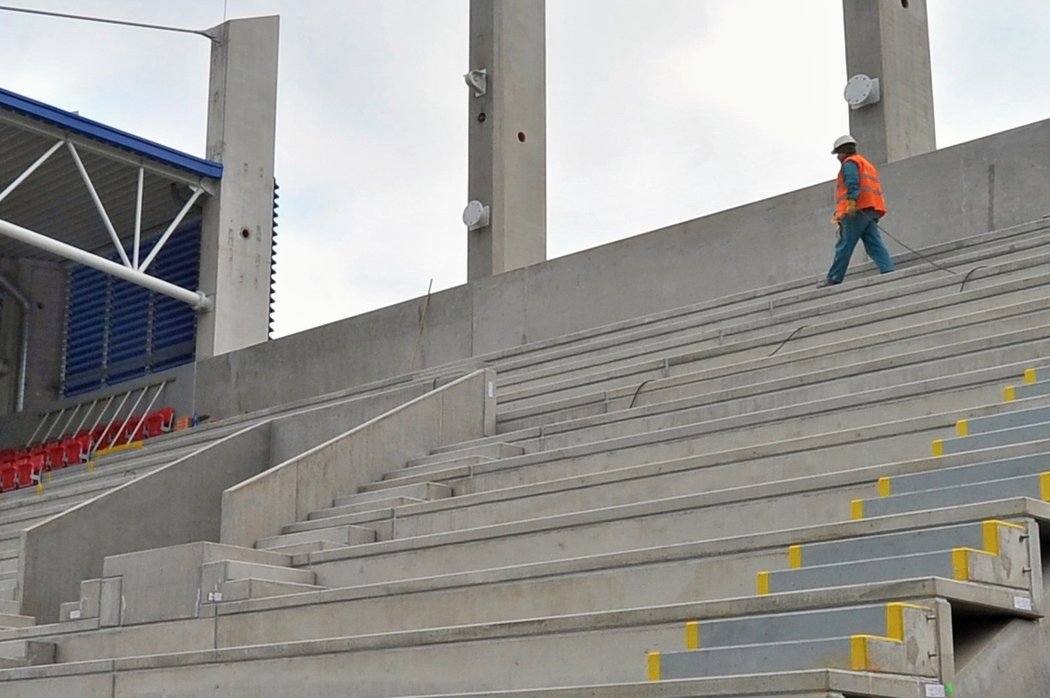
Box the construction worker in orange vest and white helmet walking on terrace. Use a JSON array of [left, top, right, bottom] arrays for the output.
[[817, 134, 894, 288]]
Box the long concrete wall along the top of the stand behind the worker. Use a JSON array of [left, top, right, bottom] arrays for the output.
[[197, 121, 1050, 416]]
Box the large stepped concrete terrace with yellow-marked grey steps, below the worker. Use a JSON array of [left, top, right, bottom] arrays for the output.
[[0, 223, 1050, 698]]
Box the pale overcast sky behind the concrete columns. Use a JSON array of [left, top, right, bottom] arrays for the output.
[[0, 0, 1050, 336]]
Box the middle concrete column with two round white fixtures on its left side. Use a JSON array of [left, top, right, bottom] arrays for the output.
[[467, 0, 547, 280]]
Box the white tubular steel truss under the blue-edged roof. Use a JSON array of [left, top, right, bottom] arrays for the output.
[[0, 138, 212, 312]]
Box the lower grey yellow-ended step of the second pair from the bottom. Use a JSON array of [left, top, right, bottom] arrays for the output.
[[756, 548, 1033, 595]]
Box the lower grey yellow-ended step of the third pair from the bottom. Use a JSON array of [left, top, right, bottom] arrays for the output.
[[853, 471, 1050, 519]]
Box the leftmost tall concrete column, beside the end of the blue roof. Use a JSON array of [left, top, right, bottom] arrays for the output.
[[196, 17, 279, 359]]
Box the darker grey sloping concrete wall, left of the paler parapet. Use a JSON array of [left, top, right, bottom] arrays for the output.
[[19, 423, 271, 622]]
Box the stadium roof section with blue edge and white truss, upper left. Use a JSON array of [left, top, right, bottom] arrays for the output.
[[0, 89, 223, 308]]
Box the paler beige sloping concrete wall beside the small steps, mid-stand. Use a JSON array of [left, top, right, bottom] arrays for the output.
[[222, 369, 496, 548]]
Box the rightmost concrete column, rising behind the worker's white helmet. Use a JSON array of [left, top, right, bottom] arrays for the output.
[[842, 0, 937, 163]]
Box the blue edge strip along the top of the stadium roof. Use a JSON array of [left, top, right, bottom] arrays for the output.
[[0, 88, 223, 179]]
